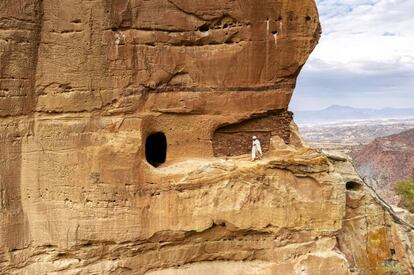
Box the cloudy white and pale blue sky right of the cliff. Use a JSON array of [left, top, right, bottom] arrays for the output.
[[290, 0, 414, 111]]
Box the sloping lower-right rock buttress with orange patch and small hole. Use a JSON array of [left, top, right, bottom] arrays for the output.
[[330, 152, 414, 275]]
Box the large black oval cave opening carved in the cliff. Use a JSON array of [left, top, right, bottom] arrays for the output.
[[145, 132, 167, 167]]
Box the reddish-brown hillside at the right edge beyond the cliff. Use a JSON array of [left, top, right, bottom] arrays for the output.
[[353, 129, 414, 205]]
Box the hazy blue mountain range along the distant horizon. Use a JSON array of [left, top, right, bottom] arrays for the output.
[[295, 105, 414, 125]]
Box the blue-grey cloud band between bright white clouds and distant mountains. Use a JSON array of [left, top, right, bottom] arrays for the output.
[[290, 65, 414, 111]]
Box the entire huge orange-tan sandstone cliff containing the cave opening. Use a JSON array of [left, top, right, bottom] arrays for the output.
[[0, 0, 413, 274]]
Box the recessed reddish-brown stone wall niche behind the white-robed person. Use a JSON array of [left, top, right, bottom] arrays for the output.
[[213, 110, 293, 157]]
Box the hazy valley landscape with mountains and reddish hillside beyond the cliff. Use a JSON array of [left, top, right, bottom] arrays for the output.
[[298, 106, 414, 209]]
